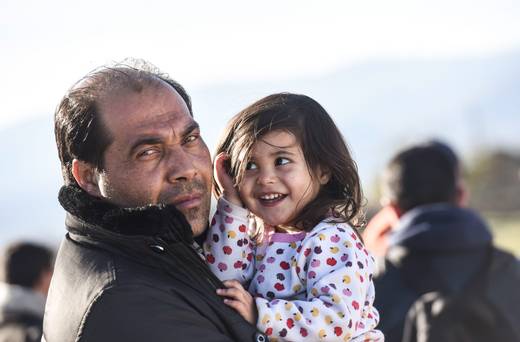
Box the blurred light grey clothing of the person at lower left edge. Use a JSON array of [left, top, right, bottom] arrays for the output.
[[0, 283, 45, 342]]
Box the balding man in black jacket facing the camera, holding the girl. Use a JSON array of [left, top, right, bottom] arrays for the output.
[[44, 62, 265, 342]]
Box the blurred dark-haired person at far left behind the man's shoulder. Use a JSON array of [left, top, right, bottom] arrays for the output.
[[0, 242, 53, 342]]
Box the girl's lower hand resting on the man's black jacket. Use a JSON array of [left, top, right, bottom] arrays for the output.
[[217, 280, 257, 326]]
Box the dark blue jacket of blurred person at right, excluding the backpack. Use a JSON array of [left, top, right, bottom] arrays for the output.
[[374, 204, 520, 342]]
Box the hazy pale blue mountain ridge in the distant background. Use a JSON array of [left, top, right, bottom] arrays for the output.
[[0, 50, 520, 243]]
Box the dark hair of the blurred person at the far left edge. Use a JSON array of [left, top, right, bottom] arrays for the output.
[[0, 242, 54, 288]]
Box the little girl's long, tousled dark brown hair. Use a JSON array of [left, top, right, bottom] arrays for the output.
[[214, 93, 362, 230]]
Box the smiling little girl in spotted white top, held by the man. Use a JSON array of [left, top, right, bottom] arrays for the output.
[[204, 93, 383, 341]]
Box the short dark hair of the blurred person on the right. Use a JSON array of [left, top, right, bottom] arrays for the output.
[[384, 141, 459, 212]]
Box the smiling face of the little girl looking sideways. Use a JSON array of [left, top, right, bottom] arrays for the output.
[[238, 130, 329, 226]]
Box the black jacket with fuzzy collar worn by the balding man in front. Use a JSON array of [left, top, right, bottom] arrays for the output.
[[43, 187, 265, 342]]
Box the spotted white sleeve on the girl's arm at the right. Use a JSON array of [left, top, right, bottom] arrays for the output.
[[256, 225, 377, 341]]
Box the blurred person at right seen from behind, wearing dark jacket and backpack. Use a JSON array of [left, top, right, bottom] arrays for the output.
[[364, 141, 520, 342]]
